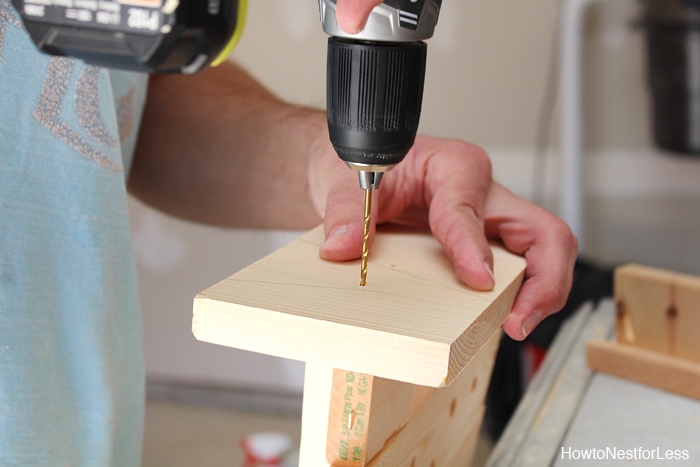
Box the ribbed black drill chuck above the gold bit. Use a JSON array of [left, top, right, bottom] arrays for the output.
[[326, 37, 427, 171]]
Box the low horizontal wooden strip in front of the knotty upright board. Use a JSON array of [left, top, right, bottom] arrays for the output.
[[586, 341, 700, 399]]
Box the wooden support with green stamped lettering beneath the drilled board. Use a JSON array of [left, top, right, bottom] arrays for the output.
[[299, 333, 500, 467]]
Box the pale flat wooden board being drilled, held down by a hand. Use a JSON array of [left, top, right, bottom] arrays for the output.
[[192, 227, 525, 387]]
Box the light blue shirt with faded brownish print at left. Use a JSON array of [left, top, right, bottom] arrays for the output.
[[0, 0, 147, 467]]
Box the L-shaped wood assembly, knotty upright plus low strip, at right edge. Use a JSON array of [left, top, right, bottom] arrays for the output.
[[586, 264, 700, 404]]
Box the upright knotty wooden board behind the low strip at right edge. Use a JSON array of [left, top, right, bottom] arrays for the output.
[[615, 264, 700, 362]]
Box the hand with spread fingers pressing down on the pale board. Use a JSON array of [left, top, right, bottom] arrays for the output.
[[311, 136, 577, 340]]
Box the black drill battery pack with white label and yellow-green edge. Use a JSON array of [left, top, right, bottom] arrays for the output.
[[12, 0, 247, 73]]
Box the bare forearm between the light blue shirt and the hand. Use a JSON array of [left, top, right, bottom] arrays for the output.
[[128, 64, 328, 229]]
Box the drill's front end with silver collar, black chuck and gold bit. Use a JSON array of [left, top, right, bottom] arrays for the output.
[[319, 0, 442, 285]]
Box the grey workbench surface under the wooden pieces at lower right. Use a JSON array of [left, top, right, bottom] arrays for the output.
[[487, 300, 700, 467]]
